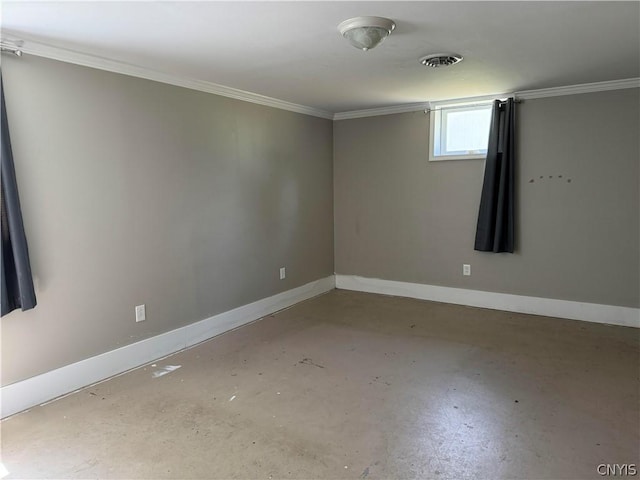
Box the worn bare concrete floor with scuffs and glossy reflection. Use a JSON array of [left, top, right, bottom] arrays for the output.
[[2, 290, 640, 479]]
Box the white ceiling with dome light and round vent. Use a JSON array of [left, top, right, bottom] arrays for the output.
[[1, 1, 640, 113]]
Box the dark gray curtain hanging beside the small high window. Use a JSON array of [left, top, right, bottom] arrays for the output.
[[475, 98, 515, 253]]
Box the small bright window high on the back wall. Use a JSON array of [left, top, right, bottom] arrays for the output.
[[429, 103, 493, 161]]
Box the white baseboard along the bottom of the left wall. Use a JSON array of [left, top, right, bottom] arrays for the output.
[[0, 275, 335, 418]]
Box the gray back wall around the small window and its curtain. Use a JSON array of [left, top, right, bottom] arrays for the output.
[[334, 89, 640, 307]]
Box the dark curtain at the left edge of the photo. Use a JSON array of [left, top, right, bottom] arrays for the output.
[[0, 77, 36, 315]]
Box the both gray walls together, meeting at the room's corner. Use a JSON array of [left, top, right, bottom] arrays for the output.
[[1, 56, 640, 385]]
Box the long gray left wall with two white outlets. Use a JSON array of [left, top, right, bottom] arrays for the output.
[[2, 55, 333, 385]]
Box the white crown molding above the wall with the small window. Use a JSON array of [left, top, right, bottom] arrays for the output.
[[333, 77, 640, 120]]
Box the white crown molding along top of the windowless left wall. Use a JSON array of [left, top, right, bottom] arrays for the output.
[[2, 31, 333, 120]]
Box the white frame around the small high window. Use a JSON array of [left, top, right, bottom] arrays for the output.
[[429, 99, 493, 162]]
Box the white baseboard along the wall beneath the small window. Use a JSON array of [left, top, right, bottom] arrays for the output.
[[336, 275, 640, 328]]
